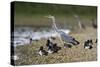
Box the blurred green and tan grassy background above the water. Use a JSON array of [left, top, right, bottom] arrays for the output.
[[14, 2, 97, 27]]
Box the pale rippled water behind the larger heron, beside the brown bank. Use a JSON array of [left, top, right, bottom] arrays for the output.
[[13, 27, 70, 46]]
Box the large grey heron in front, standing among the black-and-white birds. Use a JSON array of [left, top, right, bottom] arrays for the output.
[[46, 15, 79, 45]]
